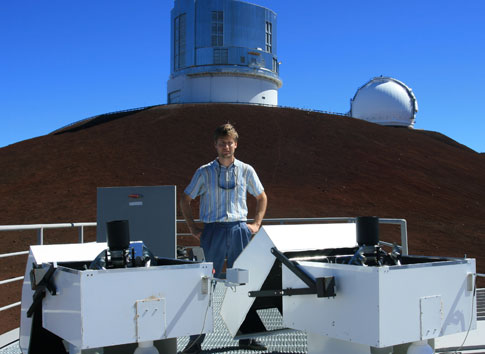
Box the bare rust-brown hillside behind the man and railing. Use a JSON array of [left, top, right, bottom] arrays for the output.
[[0, 104, 485, 333]]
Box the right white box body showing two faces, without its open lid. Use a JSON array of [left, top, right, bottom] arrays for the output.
[[283, 259, 476, 348]]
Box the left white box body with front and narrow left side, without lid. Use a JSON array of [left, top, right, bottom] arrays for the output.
[[36, 263, 213, 349]]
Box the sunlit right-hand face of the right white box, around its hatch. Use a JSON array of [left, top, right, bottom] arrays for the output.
[[379, 259, 476, 343]]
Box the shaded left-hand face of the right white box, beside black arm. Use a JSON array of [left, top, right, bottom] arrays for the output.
[[283, 262, 379, 346]]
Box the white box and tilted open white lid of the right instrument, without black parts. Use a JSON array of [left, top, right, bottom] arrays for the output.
[[221, 223, 476, 353]]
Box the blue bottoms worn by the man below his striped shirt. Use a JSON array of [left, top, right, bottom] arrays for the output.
[[200, 221, 251, 278]]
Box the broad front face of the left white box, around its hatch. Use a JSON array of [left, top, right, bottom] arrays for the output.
[[78, 263, 212, 348]]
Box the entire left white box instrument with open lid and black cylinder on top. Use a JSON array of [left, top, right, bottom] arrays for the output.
[[20, 220, 213, 354]]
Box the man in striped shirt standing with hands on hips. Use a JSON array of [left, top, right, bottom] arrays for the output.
[[180, 123, 267, 354]]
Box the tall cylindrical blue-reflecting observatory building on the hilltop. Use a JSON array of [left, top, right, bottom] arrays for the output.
[[167, 0, 282, 105]]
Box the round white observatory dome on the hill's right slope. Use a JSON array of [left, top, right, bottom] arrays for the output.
[[350, 76, 418, 128]]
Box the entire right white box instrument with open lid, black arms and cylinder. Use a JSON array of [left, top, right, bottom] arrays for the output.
[[221, 217, 476, 354]]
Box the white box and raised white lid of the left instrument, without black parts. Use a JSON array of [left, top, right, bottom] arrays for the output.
[[20, 243, 213, 353]]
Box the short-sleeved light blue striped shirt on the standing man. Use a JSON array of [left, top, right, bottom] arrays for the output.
[[185, 159, 264, 223]]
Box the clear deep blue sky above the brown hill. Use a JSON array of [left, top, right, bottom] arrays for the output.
[[0, 0, 485, 152]]
